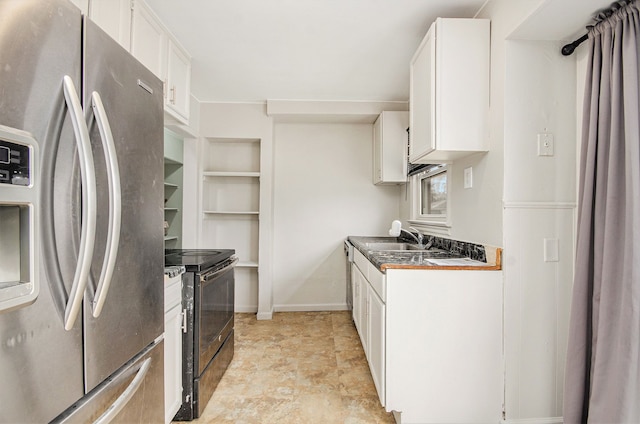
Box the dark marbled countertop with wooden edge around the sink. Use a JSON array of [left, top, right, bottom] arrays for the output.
[[348, 236, 502, 272]]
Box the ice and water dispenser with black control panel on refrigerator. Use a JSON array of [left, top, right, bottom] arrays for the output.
[[0, 125, 40, 311]]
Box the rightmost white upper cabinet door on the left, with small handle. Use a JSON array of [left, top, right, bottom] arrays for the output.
[[166, 39, 191, 124]]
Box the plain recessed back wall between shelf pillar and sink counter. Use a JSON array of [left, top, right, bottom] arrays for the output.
[[273, 123, 400, 311]]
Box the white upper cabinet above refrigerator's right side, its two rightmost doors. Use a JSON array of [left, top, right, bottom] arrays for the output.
[[131, 0, 191, 124]]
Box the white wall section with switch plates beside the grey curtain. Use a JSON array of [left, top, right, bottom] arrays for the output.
[[483, 1, 588, 422]]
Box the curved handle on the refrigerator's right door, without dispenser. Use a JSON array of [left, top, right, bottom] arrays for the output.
[[91, 91, 122, 318]]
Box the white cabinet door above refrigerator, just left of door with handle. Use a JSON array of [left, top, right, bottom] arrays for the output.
[[131, 0, 167, 79]]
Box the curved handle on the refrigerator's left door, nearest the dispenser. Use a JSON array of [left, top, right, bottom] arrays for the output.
[[63, 75, 97, 331]]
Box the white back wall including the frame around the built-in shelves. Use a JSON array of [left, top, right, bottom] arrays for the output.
[[184, 103, 404, 318]]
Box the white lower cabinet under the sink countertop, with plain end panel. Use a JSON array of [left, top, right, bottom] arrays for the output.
[[353, 250, 503, 424]]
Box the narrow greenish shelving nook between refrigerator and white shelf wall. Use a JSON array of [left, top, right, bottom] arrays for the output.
[[164, 129, 183, 249]]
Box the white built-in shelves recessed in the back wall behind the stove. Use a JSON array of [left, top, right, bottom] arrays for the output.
[[200, 138, 260, 312]]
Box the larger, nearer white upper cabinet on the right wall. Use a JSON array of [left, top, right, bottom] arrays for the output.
[[409, 18, 490, 163]]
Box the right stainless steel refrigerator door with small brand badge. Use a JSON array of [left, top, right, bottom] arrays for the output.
[[83, 20, 164, 392]]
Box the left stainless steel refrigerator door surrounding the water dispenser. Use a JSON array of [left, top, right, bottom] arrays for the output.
[[0, 0, 83, 423]]
